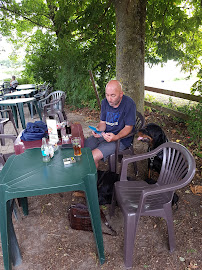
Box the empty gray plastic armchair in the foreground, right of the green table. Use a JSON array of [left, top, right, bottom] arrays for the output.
[[110, 142, 196, 268]]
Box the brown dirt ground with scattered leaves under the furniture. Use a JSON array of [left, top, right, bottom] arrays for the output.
[[0, 107, 202, 270]]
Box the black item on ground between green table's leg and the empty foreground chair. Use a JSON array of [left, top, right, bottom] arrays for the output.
[[97, 170, 120, 205]]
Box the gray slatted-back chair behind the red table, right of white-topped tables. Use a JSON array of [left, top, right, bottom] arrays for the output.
[[39, 91, 67, 122]]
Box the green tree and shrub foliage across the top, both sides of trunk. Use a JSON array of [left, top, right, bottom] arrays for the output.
[[0, 0, 202, 107]]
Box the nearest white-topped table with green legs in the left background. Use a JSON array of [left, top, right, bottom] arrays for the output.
[[0, 97, 42, 129]]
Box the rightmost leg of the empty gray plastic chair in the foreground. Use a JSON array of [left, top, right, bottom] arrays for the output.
[[164, 204, 176, 252]]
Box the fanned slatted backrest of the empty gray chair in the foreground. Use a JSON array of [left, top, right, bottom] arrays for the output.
[[158, 142, 196, 189]]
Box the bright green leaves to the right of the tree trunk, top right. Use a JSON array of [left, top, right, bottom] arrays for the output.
[[145, 0, 202, 77]]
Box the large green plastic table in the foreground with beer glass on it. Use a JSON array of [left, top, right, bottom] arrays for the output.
[[0, 148, 105, 270]]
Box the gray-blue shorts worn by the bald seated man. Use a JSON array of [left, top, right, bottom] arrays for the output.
[[84, 136, 126, 161]]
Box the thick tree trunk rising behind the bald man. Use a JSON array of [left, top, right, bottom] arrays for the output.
[[115, 0, 147, 113]]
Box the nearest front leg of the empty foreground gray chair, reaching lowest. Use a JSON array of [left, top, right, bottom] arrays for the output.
[[124, 215, 137, 268]]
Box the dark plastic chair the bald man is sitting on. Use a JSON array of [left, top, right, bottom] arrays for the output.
[[108, 111, 145, 174]]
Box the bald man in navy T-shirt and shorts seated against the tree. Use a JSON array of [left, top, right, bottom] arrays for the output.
[[85, 80, 136, 168]]
